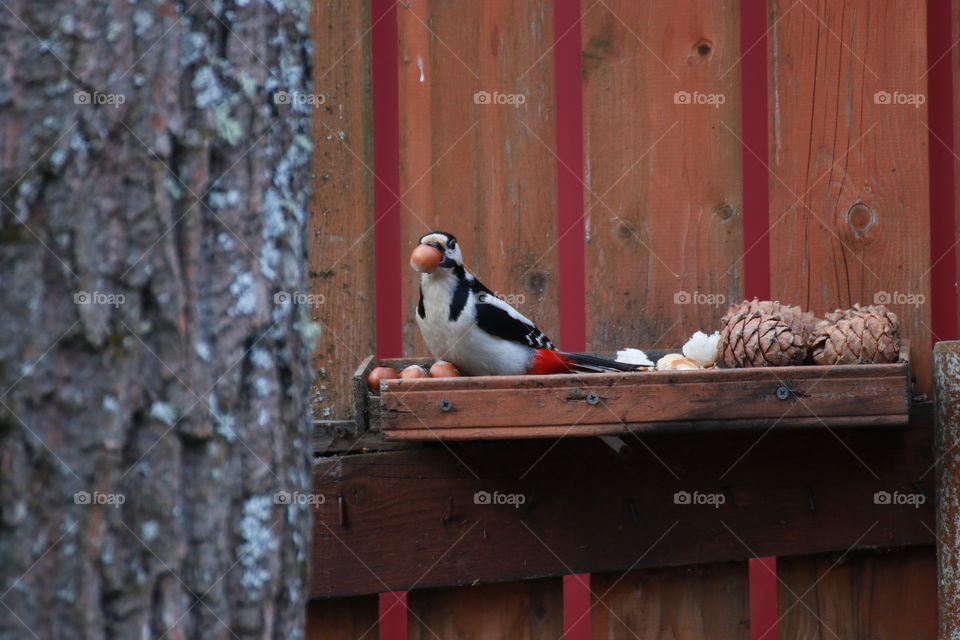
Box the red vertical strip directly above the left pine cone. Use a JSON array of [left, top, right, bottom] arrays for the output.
[[740, 0, 770, 300]]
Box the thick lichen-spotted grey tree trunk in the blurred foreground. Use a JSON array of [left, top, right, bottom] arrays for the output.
[[0, 0, 322, 640]]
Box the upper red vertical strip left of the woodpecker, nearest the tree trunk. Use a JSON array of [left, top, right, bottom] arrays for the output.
[[371, 0, 403, 358]]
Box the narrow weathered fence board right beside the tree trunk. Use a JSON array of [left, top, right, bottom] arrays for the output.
[[310, 2, 375, 419]]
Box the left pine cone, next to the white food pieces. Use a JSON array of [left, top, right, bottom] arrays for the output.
[[720, 309, 807, 368]]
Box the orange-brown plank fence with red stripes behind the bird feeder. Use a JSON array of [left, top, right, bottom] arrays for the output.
[[311, 0, 960, 639]]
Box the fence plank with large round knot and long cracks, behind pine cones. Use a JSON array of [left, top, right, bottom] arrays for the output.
[[769, 0, 931, 394]]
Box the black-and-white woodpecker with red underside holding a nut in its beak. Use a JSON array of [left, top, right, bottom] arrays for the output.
[[410, 231, 636, 376]]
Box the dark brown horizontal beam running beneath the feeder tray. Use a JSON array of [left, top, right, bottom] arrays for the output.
[[311, 411, 933, 597]]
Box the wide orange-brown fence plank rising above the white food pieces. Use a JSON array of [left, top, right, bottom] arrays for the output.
[[583, 0, 743, 349]]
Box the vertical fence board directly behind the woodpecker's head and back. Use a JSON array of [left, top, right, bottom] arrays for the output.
[[400, 0, 558, 355]]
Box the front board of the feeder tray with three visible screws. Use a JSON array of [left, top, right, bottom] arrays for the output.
[[381, 372, 909, 431]]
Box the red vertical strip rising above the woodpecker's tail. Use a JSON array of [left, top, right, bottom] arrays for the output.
[[553, 0, 587, 351]]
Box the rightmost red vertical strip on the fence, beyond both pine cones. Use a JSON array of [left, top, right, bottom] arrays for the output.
[[927, 0, 958, 340]]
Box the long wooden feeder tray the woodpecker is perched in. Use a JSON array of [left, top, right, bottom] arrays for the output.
[[354, 341, 910, 440]]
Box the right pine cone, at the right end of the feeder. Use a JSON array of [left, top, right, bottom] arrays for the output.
[[810, 305, 900, 364]]
